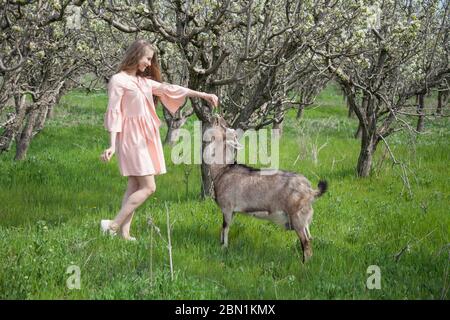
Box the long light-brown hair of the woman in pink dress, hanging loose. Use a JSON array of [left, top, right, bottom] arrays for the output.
[[118, 39, 162, 107]]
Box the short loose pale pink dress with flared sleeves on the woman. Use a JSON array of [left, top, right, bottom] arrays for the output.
[[104, 71, 189, 176]]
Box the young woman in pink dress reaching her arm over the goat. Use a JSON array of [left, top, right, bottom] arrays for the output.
[[100, 40, 219, 240]]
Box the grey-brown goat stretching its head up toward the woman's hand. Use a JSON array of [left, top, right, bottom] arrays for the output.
[[209, 117, 328, 262]]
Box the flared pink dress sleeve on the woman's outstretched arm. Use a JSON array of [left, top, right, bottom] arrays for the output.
[[149, 79, 189, 114]]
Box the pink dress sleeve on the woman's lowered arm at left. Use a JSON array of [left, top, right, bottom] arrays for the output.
[[104, 76, 124, 132]]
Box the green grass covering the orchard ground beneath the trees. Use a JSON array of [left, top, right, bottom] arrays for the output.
[[0, 86, 450, 299]]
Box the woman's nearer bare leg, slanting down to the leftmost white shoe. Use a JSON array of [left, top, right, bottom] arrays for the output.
[[112, 176, 156, 231]]
